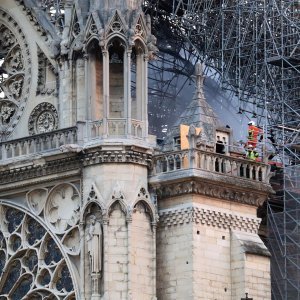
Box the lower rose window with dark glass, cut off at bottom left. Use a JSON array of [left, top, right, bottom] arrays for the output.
[[0, 205, 75, 300]]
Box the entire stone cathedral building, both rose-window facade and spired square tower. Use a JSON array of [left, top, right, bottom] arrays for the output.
[[0, 0, 270, 300]]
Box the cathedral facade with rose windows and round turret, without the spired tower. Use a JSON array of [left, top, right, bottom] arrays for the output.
[[0, 0, 156, 300]]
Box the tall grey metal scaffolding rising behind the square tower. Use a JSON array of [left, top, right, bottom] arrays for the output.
[[144, 0, 300, 299]]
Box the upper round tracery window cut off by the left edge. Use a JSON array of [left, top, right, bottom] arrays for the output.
[[0, 9, 31, 139]]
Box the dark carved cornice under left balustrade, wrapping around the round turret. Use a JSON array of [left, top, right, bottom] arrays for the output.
[[0, 146, 151, 186]]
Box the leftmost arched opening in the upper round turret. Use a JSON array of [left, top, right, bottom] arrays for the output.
[[87, 40, 104, 121]]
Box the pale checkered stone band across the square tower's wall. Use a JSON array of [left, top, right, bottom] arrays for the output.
[[158, 207, 260, 233]]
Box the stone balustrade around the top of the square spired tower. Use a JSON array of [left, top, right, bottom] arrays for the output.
[[152, 149, 270, 183]]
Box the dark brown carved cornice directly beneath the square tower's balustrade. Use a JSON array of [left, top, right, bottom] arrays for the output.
[[154, 180, 267, 206]]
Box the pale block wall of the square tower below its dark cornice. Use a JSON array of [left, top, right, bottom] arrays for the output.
[[157, 196, 271, 300]]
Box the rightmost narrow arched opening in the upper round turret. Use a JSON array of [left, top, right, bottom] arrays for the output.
[[131, 40, 144, 121]]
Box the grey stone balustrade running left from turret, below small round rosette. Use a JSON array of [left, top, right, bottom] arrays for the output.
[[0, 127, 77, 161]]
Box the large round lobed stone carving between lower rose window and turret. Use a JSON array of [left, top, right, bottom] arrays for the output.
[[45, 184, 80, 233]]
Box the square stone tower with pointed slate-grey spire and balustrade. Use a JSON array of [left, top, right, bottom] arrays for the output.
[[149, 64, 271, 300]]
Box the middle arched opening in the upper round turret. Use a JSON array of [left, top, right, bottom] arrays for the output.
[[109, 38, 125, 118]]
